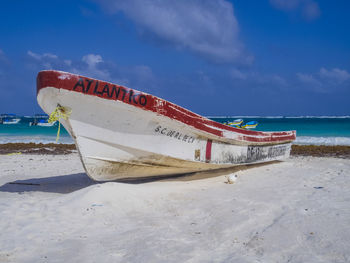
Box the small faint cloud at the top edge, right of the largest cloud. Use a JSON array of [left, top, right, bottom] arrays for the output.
[[270, 0, 321, 20]]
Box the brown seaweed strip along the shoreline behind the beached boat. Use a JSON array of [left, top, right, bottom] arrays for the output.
[[0, 143, 350, 159]]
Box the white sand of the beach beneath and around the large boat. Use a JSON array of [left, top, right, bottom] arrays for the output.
[[0, 154, 350, 263]]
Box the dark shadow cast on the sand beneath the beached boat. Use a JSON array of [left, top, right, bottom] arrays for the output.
[[0, 161, 278, 194]]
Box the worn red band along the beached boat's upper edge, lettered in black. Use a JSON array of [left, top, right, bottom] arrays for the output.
[[37, 70, 296, 143]]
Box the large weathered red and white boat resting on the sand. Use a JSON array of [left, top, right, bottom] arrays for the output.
[[37, 70, 296, 181]]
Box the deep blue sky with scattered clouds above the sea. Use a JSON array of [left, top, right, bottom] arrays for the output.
[[0, 0, 350, 116]]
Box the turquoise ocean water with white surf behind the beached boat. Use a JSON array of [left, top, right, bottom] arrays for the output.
[[0, 116, 350, 145]]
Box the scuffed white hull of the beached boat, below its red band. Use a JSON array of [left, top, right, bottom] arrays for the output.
[[37, 70, 291, 181]]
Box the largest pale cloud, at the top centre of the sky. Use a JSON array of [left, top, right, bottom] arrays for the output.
[[95, 0, 253, 64]]
